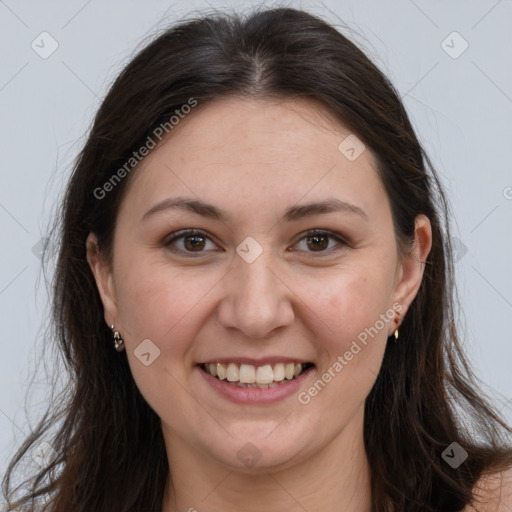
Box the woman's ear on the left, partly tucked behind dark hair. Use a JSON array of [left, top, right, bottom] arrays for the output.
[[85, 233, 118, 327]]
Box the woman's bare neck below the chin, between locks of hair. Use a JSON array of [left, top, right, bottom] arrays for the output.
[[162, 411, 371, 512]]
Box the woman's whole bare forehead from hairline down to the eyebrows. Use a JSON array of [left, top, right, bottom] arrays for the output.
[[117, 97, 385, 224]]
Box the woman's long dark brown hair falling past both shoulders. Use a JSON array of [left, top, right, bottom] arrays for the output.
[[3, 8, 512, 512]]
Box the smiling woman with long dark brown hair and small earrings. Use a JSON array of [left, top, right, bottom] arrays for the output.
[[4, 5, 512, 512]]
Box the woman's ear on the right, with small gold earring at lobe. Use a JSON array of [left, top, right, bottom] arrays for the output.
[[388, 214, 432, 335]]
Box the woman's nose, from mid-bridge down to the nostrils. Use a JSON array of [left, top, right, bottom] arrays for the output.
[[218, 250, 295, 339]]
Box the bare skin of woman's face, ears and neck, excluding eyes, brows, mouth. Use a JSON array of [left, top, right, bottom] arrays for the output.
[[87, 97, 432, 512]]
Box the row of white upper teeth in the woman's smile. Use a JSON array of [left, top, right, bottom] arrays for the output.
[[204, 363, 304, 384]]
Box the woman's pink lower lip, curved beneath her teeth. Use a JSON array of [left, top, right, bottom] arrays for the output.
[[197, 366, 315, 404]]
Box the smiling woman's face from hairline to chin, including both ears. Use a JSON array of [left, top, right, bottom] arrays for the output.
[[88, 98, 430, 471]]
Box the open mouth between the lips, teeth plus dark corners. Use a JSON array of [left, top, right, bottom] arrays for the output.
[[198, 362, 315, 389]]
